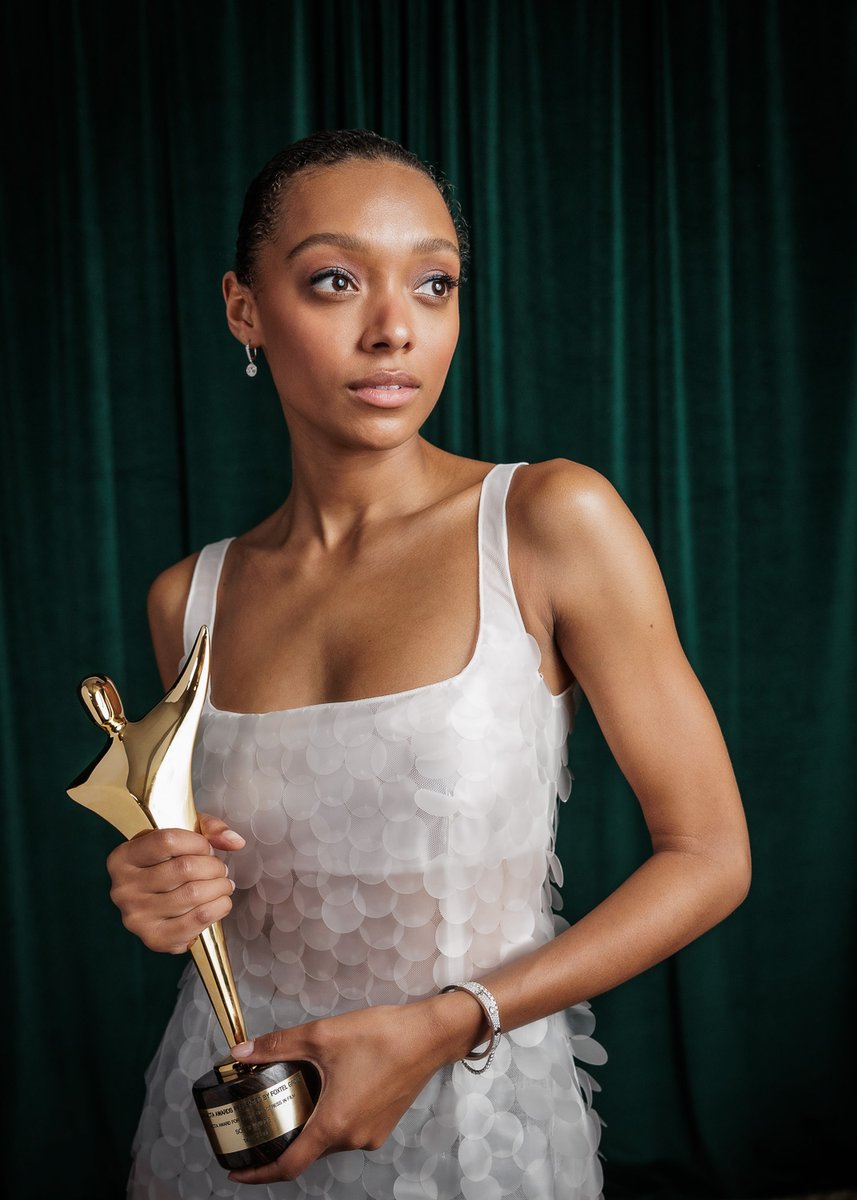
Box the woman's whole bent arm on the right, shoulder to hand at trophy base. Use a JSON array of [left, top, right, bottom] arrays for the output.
[[233, 460, 750, 1183]]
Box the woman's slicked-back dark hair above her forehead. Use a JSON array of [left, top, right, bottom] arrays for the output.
[[234, 130, 471, 287]]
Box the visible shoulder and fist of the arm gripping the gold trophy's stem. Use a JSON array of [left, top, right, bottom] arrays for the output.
[[107, 554, 244, 954]]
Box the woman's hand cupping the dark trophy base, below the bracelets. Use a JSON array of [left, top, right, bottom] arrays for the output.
[[223, 996, 470, 1183]]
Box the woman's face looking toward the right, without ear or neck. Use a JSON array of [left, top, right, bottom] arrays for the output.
[[233, 160, 461, 449]]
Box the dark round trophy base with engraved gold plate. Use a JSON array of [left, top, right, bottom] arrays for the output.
[[193, 1057, 320, 1171]]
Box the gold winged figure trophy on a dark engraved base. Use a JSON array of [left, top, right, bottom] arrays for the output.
[[68, 625, 319, 1170]]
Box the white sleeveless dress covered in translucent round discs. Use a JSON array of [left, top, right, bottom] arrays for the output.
[[128, 463, 606, 1200]]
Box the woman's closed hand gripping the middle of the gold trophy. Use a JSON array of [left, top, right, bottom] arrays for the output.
[[107, 812, 244, 954]]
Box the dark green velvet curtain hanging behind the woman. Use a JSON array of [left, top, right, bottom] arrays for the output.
[[0, 0, 857, 1200]]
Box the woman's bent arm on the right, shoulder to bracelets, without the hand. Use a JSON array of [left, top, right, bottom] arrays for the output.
[[427, 460, 750, 1054]]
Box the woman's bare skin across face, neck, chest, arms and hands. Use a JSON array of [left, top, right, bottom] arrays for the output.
[[108, 162, 750, 1183]]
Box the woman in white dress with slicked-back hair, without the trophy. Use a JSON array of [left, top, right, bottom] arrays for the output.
[[109, 131, 750, 1200]]
